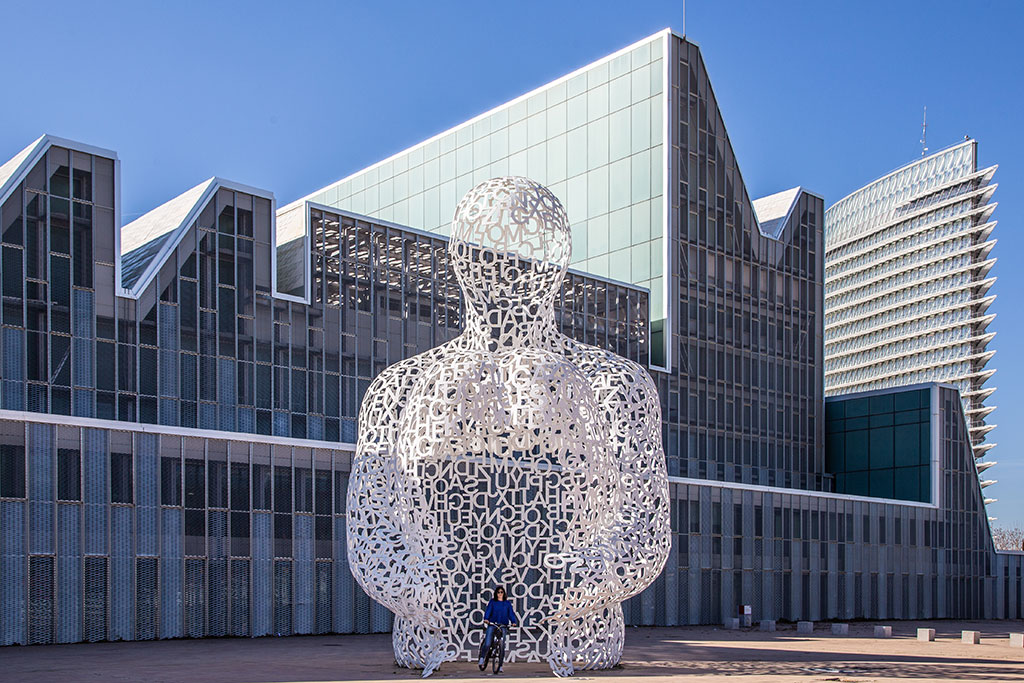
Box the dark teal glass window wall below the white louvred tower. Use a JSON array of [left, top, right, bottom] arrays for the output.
[[825, 388, 932, 503]]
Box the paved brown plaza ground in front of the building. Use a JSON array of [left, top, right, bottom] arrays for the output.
[[0, 621, 1024, 683]]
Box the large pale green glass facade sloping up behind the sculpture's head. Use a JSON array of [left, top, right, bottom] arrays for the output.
[[299, 33, 667, 335]]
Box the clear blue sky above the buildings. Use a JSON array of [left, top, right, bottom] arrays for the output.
[[0, 0, 1024, 523]]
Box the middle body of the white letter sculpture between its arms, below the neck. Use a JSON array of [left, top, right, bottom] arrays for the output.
[[391, 344, 617, 660]]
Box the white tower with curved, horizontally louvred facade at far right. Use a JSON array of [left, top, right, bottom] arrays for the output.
[[825, 139, 996, 499]]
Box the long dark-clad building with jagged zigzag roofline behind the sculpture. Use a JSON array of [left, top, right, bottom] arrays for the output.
[[0, 32, 1024, 644]]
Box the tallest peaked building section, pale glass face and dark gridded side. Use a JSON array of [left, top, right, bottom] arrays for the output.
[[299, 31, 826, 489]]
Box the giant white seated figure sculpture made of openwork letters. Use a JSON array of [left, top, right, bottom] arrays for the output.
[[347, 177, 670, 676]]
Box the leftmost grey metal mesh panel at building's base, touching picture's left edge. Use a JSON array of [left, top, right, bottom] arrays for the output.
[[0, 501, 27, 645]]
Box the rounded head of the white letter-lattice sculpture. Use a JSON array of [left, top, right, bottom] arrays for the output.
[[449, 176, 572, 311]]
